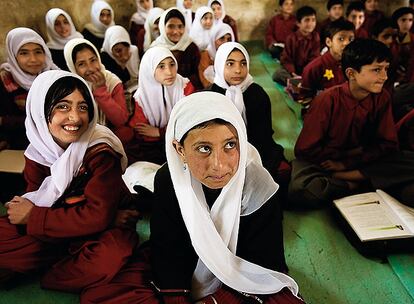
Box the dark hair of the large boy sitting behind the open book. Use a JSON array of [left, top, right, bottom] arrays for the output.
[[341, 38, 391, 75]]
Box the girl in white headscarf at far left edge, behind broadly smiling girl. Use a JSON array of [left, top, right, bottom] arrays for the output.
[[0, 27, 58, 150]]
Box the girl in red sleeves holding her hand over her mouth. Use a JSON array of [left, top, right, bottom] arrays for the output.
[[64, 38, 130, 142]]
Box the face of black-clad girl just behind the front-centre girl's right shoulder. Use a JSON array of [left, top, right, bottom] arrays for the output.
[[224, 50, 249, 85]]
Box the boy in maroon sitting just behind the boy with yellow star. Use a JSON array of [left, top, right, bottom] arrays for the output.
[[273, 6, 320, 85]]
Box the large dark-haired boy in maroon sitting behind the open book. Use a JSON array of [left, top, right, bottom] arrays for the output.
[[289, 39, 414, 207]]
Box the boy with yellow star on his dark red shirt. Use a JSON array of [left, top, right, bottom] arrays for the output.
[[301, 19, 355, 96]]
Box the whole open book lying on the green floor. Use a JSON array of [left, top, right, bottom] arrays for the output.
[[334, 190, 414, 242]]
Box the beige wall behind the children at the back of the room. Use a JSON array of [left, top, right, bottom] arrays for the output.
[[0, 0, 408, 62]]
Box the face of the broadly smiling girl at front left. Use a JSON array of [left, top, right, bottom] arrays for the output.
[[48, 90, 89, 149]]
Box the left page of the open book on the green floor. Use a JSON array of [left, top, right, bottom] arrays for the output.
[[334, 192, 414, 241]]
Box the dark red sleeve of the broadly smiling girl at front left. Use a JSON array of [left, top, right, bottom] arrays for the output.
[[27, 152, 123, 238]]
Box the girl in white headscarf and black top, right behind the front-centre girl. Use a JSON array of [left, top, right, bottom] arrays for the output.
[[211, 42, 290, 195]]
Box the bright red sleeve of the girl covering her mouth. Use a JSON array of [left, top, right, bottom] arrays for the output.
[[93, 83, 128, 127]]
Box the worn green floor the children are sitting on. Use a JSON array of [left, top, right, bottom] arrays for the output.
[[0, 43, 414, 304]]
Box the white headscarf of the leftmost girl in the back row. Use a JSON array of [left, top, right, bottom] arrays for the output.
[[45, 8, 83, 50]]
